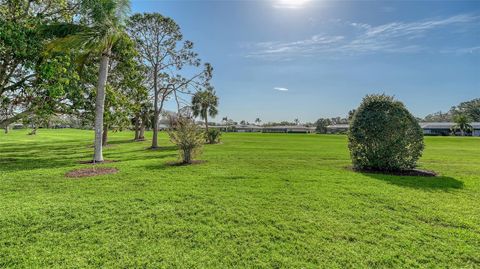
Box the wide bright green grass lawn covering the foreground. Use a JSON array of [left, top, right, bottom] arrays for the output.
[[0, 129, 480, 268]]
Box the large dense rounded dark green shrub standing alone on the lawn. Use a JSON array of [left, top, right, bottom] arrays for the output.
[[348, 94, 424, 171]]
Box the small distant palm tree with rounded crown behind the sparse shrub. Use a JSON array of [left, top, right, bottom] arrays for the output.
[[192, 86, 218, 133]]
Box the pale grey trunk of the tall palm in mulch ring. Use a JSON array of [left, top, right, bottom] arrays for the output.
[[93, 48, 111, 163]]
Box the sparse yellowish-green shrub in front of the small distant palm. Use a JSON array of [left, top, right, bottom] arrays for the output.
[[168, 117, 204, 164]]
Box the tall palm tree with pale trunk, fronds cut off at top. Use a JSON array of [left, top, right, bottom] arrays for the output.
[[48, 0, 130, 162]]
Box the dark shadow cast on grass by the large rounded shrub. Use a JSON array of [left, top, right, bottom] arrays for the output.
[[362, 173, 463, 191]]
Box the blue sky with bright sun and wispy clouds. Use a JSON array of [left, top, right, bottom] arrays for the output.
[[132, 0, 480, 122]]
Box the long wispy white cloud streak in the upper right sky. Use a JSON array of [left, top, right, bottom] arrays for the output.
[[246, 14, 480, 60]]
